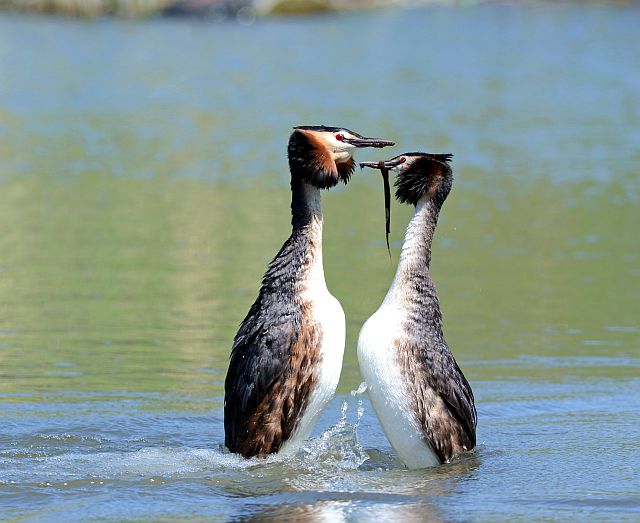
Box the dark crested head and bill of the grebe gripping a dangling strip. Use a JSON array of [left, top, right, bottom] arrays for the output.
[[360, 152, 453, 207]]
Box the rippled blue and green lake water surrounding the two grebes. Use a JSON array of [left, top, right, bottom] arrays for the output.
[[0, 4, 640, 522]]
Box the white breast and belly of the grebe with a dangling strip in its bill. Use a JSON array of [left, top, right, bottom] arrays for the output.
[[358, 301, 440, 468]]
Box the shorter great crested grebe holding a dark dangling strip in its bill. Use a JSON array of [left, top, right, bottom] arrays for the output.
[[358, 152, 477, 468]]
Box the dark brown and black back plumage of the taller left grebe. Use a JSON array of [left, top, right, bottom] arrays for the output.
[[224, 231, 321, 457]]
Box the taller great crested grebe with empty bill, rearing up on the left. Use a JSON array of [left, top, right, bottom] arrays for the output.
[[224, 126, 394, 457]]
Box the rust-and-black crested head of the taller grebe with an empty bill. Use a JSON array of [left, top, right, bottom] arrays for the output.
[[288, 125, 394, 189]]
